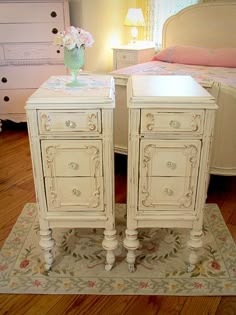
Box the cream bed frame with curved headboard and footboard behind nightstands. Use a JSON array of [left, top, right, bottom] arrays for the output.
[[113, 1, 236, 175]]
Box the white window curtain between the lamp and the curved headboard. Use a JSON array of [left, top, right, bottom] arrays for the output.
[[146, 0, 200, 49]]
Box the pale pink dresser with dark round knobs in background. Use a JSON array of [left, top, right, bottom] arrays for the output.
[[0, 0, 70, 131]]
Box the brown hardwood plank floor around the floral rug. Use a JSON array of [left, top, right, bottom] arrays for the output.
[[0, 123, 236, 315]]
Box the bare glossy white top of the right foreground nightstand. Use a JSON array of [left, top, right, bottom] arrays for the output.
[[128, 75, 216, 108]]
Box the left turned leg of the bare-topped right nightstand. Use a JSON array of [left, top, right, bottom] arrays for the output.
[[124, 229, 139, 272]]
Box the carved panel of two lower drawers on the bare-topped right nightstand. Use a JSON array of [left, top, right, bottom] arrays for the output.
[[139, 140, 201, 210]]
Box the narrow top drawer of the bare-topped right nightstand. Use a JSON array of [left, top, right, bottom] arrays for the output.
[[141, 109, 204, 134]]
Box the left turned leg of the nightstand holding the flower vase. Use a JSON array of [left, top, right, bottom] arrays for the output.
[[39, 229, 55, 270]]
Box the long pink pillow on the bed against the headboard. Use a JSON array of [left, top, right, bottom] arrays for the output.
[[152, 46, 236, 68]]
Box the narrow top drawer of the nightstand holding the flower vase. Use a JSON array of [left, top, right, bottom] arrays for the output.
[[38, 110, 101, 134]]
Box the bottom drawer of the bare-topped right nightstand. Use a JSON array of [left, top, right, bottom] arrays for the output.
[[139, 177, 197, 211]]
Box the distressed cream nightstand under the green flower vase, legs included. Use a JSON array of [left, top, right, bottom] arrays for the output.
[[26, 75, 117, 270]]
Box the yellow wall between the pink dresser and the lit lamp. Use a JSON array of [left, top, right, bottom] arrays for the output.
[[69, 0, 136, 73]]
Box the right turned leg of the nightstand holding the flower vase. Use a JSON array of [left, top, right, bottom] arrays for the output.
[[102, 230, 118, 271]]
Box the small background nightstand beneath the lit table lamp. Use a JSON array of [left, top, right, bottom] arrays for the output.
[[113, 41, 155, 70]]
